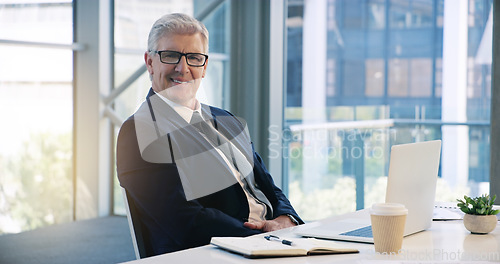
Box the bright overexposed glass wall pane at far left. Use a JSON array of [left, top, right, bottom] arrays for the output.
[[0, 0, 73, 234]]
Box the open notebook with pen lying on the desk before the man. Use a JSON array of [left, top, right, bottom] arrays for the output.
[[210, 235, 359, 258]]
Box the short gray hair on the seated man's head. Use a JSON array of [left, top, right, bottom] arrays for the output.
[[148, 13, 208, 53]]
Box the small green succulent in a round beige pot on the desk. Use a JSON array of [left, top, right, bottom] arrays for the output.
[[457, 194, 500, 234]]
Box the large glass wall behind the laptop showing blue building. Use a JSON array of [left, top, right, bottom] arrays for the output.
[[283, 0, 492, 220]]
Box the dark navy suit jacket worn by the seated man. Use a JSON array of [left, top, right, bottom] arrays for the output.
[[117, 90, 303, 255]]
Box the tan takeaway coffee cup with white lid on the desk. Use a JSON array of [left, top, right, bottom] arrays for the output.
[[370, 203, 408, 254]]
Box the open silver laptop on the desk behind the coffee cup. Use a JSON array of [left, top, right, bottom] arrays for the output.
[[295, 140, 441, 243]]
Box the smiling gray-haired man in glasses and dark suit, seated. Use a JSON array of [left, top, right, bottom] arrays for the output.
[[117, 14, 303, 255]]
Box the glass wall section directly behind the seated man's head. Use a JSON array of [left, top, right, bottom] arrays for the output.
[[113, 0, 230, 214]]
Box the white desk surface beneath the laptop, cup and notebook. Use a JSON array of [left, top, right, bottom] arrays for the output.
[[123, 220, 500, 264]]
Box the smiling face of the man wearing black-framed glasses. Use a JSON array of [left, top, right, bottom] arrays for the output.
[[144, 33, 208, 108]]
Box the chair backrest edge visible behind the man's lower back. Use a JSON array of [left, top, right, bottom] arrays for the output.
[[121, 188, 153, 259]]
